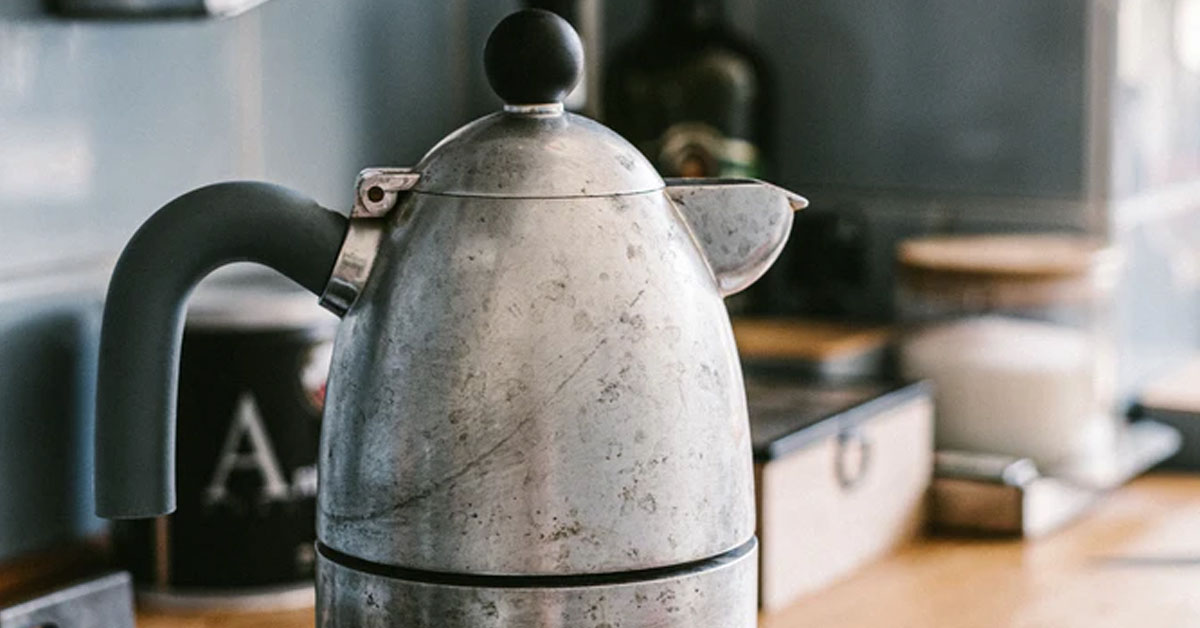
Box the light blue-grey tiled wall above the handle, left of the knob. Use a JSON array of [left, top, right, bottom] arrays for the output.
[[0, 0, 520, 279]]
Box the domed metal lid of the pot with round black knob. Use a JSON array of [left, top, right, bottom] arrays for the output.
[[413, 10, 664, 198]]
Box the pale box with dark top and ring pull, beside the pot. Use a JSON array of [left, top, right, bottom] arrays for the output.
[[746, 377, 934, 610]]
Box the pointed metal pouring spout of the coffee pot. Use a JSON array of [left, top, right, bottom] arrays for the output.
[[666, 179, 809, 297]]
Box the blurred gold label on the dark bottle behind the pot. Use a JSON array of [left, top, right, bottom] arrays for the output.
[[647, 122, 761, 177]]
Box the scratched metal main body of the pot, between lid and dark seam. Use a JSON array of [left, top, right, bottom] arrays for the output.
[[318, 192, 754, 574]]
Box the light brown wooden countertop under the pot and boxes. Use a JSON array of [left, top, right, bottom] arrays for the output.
[[138, 474, 1200, 628]]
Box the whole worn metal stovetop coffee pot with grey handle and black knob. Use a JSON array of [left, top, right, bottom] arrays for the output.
[[96, 10, 806, 628]]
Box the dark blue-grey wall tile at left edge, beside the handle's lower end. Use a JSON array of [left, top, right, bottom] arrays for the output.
[[0, 289, 100, 558]]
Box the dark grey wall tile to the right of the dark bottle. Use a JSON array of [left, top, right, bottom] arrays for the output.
[[757, 0, 1087, 198]]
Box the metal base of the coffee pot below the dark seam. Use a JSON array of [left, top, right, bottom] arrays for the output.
[[317, 540, 758, 628]]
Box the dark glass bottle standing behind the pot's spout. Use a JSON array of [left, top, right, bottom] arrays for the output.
[[604, 0, 770, 177]]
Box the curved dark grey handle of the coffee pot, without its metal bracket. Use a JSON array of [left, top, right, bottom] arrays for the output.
[[96, 181, 347, 519]]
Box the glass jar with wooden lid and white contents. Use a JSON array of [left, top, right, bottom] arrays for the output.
[[899, 234, 1120, 467]]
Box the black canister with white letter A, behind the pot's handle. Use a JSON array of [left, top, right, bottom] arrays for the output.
[[114, 270, 337, 608]]
